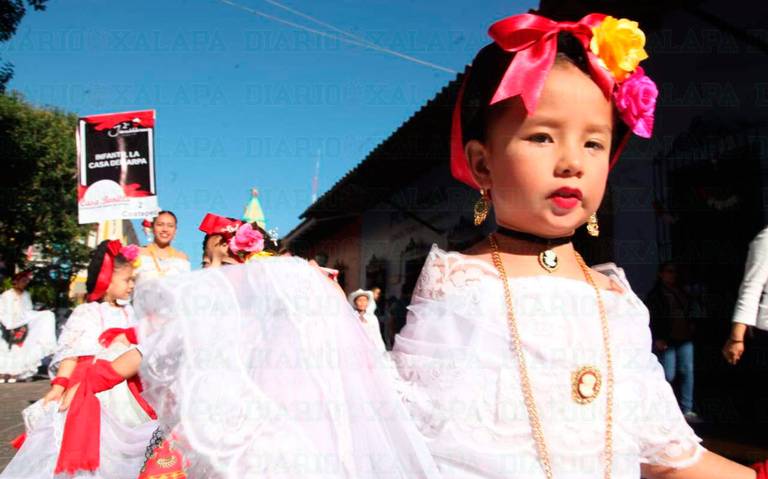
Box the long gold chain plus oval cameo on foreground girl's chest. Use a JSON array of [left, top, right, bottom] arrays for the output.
[[488, 234, 613, 479]]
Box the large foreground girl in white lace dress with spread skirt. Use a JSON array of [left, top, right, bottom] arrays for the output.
[[130, 10, 764, 479]]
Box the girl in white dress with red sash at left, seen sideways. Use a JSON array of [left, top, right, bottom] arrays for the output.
[[0, 240, 156, 479]]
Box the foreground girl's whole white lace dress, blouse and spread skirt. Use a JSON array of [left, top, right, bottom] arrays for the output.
[[130, 247, 703, 479]]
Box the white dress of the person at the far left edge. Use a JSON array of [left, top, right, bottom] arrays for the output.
[[0, 289, 56, 379]]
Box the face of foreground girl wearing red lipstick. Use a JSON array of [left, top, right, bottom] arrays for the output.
[[466, 62, 613, 237]]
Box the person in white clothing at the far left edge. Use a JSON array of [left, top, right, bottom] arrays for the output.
[[0, 271, 56, 383]]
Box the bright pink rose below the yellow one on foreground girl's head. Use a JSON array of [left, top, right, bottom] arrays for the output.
[[613, 67, 659, 138]]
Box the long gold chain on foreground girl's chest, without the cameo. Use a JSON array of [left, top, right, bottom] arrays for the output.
[[488, 235, 613, 479]]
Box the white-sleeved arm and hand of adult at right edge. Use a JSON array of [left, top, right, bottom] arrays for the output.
[[723, 228, 768, 365]]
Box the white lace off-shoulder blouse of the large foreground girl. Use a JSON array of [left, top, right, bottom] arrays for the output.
[[393, 246, 703, 479]]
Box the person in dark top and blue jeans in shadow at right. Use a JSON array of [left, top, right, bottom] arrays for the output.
[[645, 263, 698, 421]]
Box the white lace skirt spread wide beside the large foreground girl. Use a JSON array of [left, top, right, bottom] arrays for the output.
[[134, 258, 439, 479]]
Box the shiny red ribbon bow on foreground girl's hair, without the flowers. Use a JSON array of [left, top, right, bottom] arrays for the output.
[[451, 13, 632, 189]]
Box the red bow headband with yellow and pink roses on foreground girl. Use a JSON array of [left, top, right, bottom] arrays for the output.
[[451, 13, 658, 189]]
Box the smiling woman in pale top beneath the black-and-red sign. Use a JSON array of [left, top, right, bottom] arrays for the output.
[[135, 210, 192, 282]]
